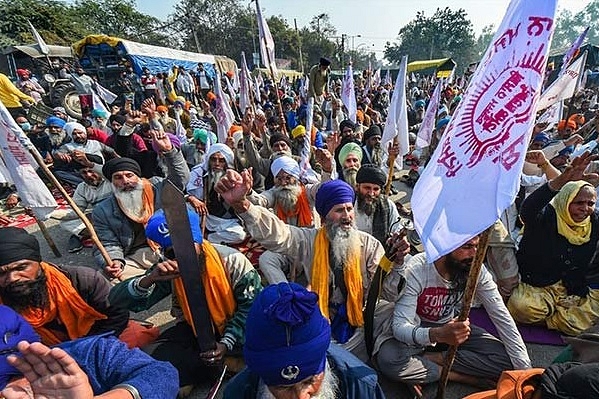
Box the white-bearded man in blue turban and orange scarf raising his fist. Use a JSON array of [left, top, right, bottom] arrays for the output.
[[215, 170, 409, 360]]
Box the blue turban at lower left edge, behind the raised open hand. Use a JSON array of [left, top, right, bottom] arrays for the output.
[[0, 305, 40, 390]]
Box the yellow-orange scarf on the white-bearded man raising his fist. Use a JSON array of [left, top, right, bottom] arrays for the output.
[[310, 227, 364, 327]]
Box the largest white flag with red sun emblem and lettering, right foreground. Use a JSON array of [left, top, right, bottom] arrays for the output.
[[411, 0, 556, 262]]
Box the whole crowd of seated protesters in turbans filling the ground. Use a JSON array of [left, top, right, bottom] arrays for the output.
[[0, 50, 599, 398]]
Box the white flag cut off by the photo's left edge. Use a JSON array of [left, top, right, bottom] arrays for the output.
[[0, 102, 57, 220]]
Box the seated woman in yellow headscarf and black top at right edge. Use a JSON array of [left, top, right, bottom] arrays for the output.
[[508, 153, 599, 335]]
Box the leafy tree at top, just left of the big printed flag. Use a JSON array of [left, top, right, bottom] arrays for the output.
[[385, 7, 476, 74]]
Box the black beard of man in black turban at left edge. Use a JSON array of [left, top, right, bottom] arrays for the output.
[[0, 272, 50, 312]]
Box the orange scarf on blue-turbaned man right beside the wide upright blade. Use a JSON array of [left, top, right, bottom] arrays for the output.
[[174, 240, 237, 336]]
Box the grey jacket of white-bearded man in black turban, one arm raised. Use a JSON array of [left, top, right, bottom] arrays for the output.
[[92, 149, 189, 270]]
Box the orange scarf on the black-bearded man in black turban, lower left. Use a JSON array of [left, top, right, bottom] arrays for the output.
[[15, 262, 106, 345]]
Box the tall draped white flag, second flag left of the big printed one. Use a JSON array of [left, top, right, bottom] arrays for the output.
[[381, 55, 410, 169]]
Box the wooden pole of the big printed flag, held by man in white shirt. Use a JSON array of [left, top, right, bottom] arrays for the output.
[[437, 226, 493, 399]]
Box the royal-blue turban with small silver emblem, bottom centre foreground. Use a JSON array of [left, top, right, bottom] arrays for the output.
[[243, 282, 331, 386]]
